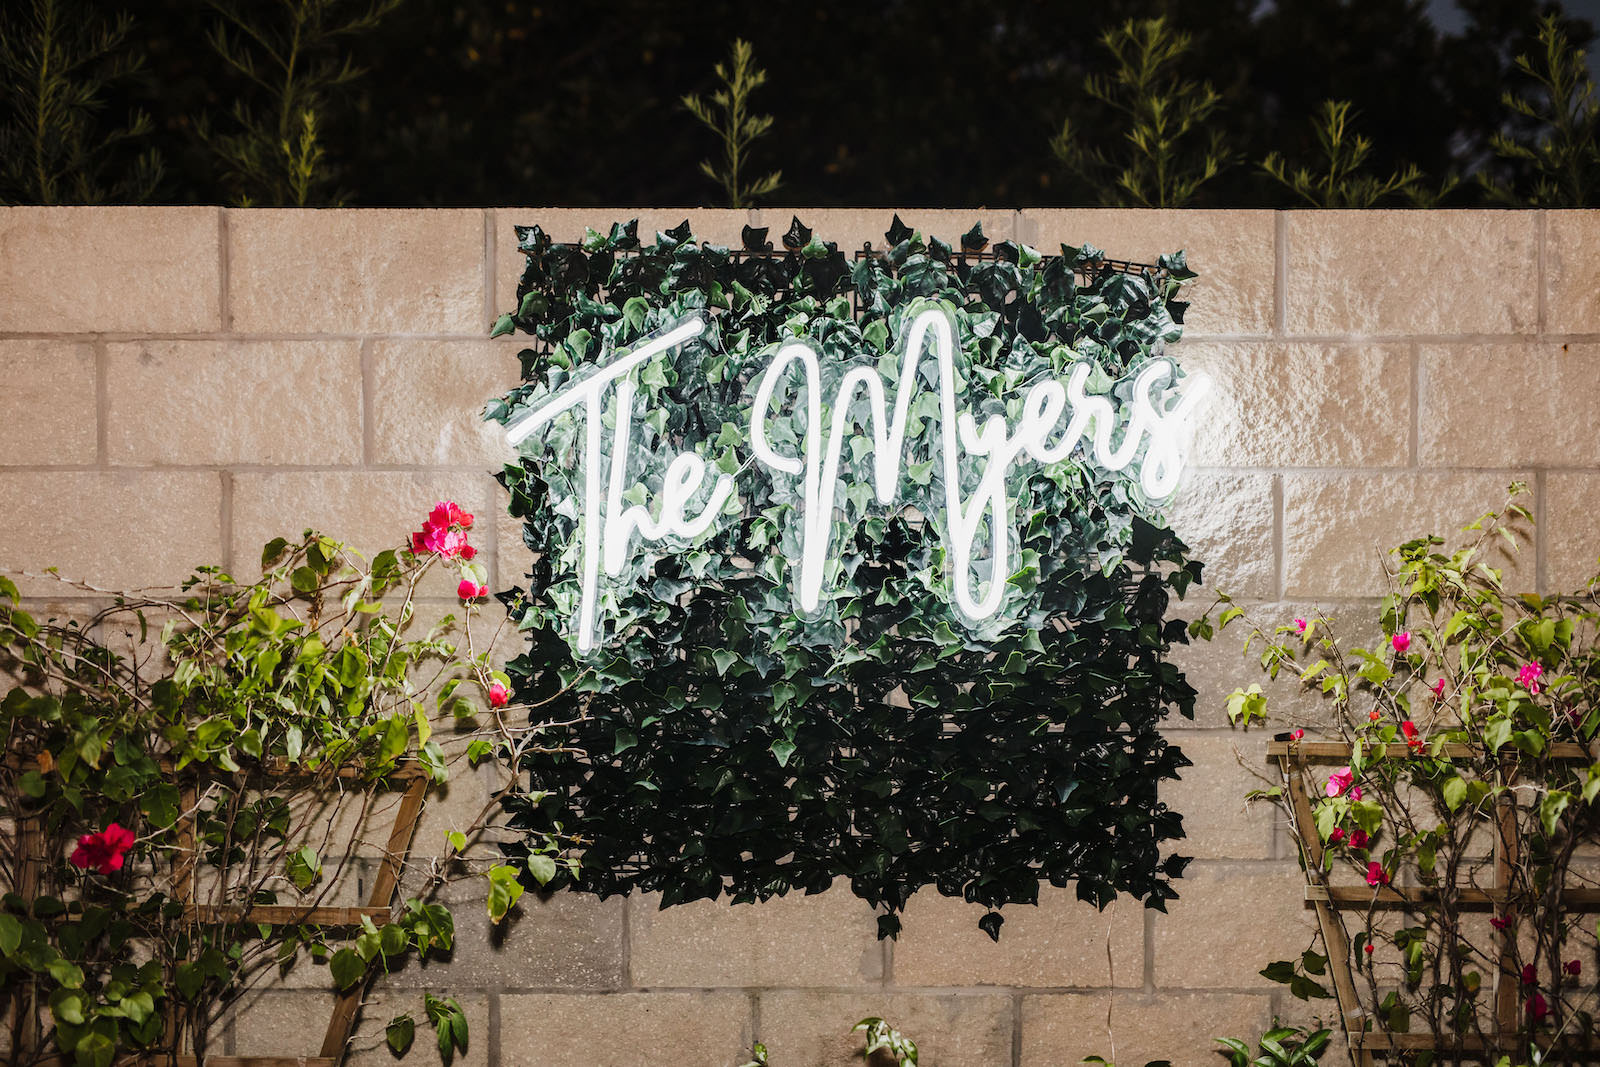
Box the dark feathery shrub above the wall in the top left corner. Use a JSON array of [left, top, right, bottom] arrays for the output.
[[0, 0, 162, 203]]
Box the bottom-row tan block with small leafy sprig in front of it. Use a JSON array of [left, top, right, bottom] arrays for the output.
[[760, 990, 1013, 1067]]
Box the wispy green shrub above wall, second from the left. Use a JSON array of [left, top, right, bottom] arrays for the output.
[[197, 0, 400, 208]]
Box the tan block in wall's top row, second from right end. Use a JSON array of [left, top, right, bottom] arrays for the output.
[[1285, 211, 1539, 336]]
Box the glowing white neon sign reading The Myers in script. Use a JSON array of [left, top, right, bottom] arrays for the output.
[[506, 306, 1210, 653]]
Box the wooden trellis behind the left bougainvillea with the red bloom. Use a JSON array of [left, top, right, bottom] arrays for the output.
[[7, 766, 427, 1067]]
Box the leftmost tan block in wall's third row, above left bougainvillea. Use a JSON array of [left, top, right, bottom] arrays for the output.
[[0, 470, 222, 597]]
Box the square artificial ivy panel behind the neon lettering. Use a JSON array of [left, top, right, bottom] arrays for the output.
[[488, 219, 1200, 936]]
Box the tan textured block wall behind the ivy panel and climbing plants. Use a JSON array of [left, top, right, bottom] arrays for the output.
[[0, 208, 1600, 1067]]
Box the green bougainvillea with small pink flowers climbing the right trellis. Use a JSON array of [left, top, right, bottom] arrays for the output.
[[1203, 485, 1600, 1062]]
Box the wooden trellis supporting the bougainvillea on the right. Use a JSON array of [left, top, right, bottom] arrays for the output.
[[1267, 741, 1600, 1067]]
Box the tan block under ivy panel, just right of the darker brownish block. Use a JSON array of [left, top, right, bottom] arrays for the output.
[[629, 880, 883, 987]]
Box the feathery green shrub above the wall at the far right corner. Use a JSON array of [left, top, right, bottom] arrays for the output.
[[1482, 14, 1600, 208]]
